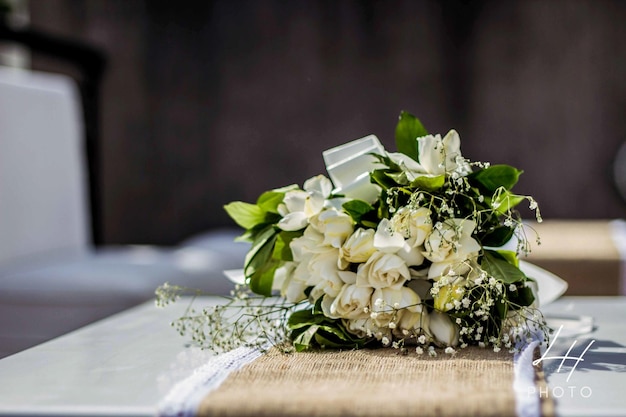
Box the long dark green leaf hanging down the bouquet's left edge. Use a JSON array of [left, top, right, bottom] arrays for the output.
[[244, 225, 278, 297]]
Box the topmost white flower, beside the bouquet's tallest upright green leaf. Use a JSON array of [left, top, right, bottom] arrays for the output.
[[417, 129, 471, 175]]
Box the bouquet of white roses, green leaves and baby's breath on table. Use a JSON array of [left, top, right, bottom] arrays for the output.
[[157, 112, 545, 355]]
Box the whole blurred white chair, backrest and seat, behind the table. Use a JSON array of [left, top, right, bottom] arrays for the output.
[[0, 26, 247, 357]]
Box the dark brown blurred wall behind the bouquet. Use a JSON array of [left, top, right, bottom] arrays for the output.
[[23, 0, 626, 244]]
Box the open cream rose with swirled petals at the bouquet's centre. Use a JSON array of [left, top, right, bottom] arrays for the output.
[[356, 252, 411, 288]]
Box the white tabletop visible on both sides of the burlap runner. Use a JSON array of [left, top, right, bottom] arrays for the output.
[[0, 297, 626, 417]]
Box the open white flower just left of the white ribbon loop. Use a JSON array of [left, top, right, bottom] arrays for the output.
[[278, 175, 333, 231]]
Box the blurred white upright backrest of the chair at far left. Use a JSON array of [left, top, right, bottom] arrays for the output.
[[0, 67, 90, 266]]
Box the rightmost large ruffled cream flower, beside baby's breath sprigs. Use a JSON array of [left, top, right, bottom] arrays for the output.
[[422, 219, 481, 278]]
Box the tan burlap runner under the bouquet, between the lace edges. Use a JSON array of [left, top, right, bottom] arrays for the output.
[[198, 348, 545, 417]]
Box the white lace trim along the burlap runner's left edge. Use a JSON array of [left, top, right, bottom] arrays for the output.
[[157, 347, 263, 417]]
